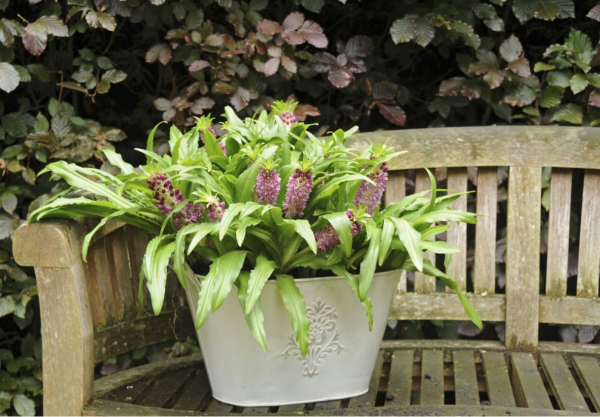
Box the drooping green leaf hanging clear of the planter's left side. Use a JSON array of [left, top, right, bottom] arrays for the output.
[[142, 235, 175, 315]]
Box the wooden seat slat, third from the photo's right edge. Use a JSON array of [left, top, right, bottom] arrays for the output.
[[511, 352, 552, 410]]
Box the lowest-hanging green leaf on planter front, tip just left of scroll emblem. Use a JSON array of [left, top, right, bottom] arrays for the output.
[[277, 275, 310, 358]]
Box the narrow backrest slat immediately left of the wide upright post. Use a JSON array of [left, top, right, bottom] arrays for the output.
[[473, 167, 498, 295]]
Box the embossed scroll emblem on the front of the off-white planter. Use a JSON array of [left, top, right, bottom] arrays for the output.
[[282, 298, 344, 377]]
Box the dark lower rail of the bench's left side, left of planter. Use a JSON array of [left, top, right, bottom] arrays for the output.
[[94, 308, 196, 363]]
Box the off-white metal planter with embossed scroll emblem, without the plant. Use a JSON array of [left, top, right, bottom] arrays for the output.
[[187, 270, 400, 407]]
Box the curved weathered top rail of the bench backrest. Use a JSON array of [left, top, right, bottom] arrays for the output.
[[347, 126, 600, 169]]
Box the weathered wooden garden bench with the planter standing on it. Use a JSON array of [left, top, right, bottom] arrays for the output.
[[14, 127, 600, 415]]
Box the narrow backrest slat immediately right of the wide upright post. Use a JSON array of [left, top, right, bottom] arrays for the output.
[[546, 168, 573, 297]]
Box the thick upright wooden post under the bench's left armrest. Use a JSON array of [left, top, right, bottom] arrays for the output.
[[36, 259, 94, 415]]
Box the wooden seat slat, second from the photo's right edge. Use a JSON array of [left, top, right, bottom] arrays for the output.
[[540, 353, 590, 412]]
